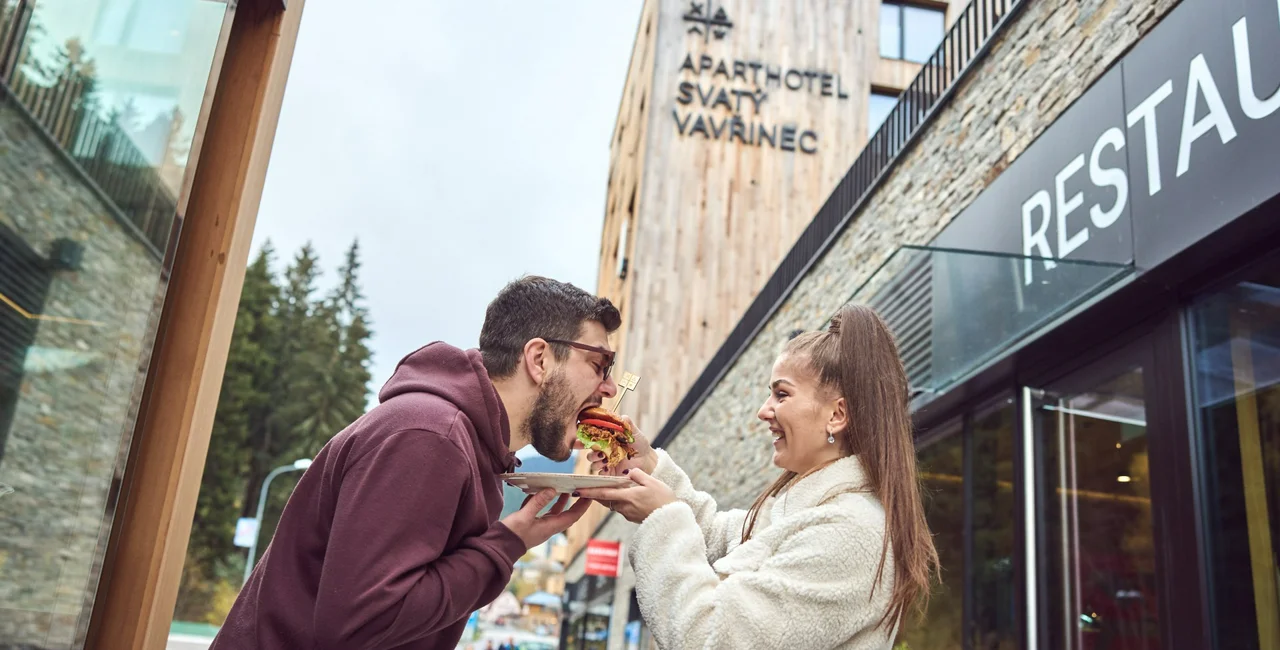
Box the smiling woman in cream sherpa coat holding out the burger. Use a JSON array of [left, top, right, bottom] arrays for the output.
[[580, 306, 938, 650]]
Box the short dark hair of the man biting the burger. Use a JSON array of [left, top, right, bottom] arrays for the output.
[[480, 275, 622, 379]]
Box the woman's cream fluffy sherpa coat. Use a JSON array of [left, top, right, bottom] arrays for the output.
[[628, 450, 893, 650]]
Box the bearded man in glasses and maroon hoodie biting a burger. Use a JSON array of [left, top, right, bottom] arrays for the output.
[[211, 278, 621, 650]]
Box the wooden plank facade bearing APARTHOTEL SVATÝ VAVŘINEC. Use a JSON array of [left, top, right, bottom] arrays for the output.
[[570, 0, 960, 557]]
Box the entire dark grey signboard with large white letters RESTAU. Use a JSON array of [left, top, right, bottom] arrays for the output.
[[934, 0, 1280, 271]]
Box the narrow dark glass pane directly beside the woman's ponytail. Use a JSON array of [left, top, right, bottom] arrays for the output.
[[899, 427, 964, 647]]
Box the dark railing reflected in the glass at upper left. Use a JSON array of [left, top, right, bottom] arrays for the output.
[[0, 0, 180, 251]]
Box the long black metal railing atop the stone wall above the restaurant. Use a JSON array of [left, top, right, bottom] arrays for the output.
[[654, 0, 1030, 445]]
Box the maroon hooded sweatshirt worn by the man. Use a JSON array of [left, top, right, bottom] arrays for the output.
[[211, 343, 526, 650]]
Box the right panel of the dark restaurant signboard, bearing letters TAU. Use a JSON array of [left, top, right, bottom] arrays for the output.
[[1124, 0, 1280, 269]]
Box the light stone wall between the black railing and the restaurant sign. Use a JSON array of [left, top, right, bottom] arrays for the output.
[[668, 0, 1178, 508]]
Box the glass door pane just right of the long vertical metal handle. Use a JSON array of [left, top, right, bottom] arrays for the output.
[[1041, 369, 1160, 650]]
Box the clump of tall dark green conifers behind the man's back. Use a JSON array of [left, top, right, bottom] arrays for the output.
[[175, 243, 372, 623]]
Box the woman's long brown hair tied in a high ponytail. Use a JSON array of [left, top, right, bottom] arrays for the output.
[[742, 305, 938, 627]]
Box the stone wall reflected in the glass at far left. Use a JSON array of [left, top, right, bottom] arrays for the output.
[[0, 99, 161, 649]]
